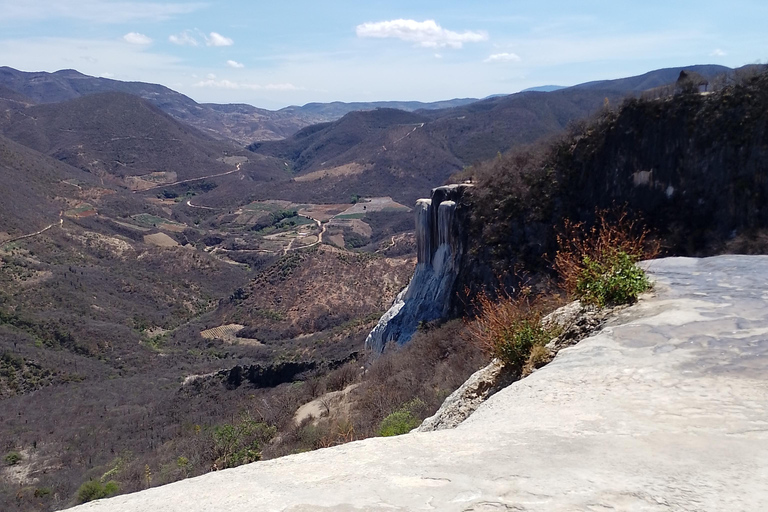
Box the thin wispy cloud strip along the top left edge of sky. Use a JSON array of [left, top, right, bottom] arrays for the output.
[[0, 0, 205, 23]]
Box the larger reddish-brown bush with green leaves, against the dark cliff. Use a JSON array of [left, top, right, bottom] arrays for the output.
[[553, 209, 660, 307]]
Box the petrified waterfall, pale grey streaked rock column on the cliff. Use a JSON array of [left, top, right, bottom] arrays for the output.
[[365, 185, 471, 353]]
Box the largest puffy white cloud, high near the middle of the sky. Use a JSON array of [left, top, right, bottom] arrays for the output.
[[355, 19, 488, 48]]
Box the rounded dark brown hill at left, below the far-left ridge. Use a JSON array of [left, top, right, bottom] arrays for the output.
[[0, 93, 249, 180]]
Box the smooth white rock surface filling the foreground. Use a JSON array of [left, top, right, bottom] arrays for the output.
[[66, 256, 768, 512]]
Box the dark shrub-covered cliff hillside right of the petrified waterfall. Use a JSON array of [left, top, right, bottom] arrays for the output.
[[457, 64, 768, 304]]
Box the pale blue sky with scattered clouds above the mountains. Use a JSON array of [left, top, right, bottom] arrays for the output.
[[0, 0, 768, 109]]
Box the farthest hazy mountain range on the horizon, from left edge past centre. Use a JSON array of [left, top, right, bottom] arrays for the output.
[[0, 67, 476, 144]]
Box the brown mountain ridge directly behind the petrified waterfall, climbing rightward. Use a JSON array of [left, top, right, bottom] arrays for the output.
[[249, 66, 729, 204]]
